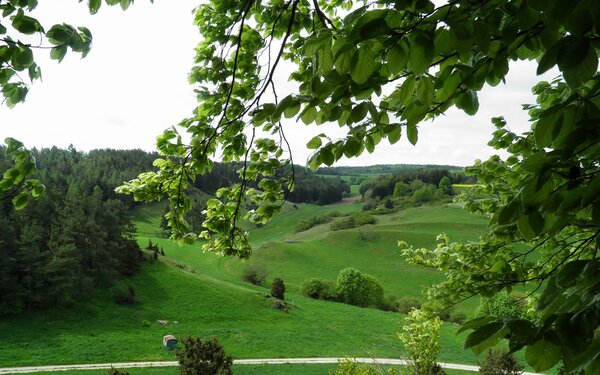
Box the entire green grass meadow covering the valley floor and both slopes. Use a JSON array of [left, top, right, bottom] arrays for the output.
[[0, 201, 528, 374]]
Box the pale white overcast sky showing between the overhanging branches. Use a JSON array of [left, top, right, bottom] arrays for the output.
[[0, 0, 552, 165]]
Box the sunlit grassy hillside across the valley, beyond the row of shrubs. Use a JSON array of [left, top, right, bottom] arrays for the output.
[[163, 203, 485, 310]]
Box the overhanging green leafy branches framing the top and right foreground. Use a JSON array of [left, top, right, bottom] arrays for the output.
[[0, 0, 600, 373]]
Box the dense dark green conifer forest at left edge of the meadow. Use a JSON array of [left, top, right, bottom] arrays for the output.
[[0, 147, 155, 314]]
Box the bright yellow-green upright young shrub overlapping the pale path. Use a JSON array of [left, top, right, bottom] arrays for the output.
[[398, 310, 443, 375]]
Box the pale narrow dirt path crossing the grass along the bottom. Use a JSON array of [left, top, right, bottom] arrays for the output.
[[0, 358, 542, 375]]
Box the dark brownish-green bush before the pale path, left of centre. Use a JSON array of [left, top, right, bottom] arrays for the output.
[[176, 337, 233, 375]]
